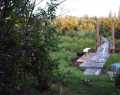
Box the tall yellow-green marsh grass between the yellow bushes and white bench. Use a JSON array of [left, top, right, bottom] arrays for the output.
[[59, 31, 95, 52]]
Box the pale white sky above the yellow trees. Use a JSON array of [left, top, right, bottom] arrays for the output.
[[35, 0, 120, 17]]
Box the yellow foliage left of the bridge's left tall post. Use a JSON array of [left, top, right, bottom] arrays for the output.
[[55, 16, 95, 32]]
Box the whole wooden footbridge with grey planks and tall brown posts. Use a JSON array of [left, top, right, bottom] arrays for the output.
[[76, 21, 115, 75]]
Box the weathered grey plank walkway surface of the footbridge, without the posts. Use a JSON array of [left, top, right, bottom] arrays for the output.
[[79, 38, 109, 75]]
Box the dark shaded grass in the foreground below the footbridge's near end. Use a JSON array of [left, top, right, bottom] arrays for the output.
[[63, 76, 114, 95]]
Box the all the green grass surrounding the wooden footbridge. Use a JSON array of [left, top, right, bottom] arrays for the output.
[[52, 31, 120, 95]]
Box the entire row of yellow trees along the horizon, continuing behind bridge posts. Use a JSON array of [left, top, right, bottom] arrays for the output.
[[54, 16, 120, 34]]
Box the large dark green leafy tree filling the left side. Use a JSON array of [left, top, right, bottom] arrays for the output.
[[0, 0, 62, 95]]
